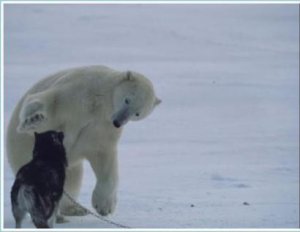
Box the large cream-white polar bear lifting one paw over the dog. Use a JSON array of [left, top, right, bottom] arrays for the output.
[[7, 66, 161, 215]]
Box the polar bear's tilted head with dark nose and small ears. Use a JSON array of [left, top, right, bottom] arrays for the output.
[[112, 71, 161, 128]]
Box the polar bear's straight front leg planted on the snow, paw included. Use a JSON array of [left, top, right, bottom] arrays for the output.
[[88, 152, 118, 216]]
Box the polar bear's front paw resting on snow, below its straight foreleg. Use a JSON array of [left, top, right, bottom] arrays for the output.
[[93, 191, 117, 216]]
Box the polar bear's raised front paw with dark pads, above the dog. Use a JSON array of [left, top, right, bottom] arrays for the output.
[[18, 101, 47, 132]]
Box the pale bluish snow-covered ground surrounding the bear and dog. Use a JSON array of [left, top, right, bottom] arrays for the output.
[[4, 4, 299, 228]]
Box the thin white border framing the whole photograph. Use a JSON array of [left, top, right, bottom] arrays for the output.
[[0, 0, 300, 232]]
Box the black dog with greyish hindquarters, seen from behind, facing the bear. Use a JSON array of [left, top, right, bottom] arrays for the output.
[[11, 131, 67, 228]]
